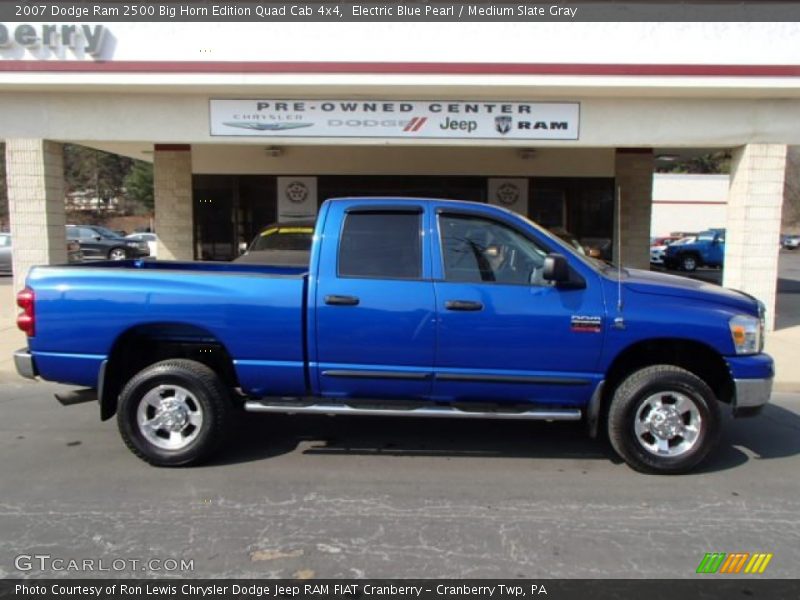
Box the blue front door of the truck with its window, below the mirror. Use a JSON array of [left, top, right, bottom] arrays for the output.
[[434, 213, 606, 404]]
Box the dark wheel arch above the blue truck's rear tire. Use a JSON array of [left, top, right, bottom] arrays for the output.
[[98, 323, 239, 421]]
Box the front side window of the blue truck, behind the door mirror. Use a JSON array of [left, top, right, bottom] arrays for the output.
[[439, 214, 547, 285]]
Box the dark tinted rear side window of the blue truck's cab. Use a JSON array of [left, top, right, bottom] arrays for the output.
[[338, 211, 422, 279]]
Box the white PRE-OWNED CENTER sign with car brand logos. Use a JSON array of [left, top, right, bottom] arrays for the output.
[[210, 100, 580, 140]]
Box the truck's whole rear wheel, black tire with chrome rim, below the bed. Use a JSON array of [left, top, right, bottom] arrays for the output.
[[117, 359, 232, 467]]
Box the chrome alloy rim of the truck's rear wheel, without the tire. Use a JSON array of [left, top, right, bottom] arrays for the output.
[[136, 385, 203, 450]]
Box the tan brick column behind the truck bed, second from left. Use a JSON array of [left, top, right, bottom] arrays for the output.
[[153, 144, 194, 260]]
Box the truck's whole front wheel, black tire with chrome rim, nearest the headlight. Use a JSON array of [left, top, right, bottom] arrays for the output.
[[608, 365, 721, 474]]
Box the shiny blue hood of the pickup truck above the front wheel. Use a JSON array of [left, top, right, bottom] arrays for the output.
[[622, 269, 758, 316]]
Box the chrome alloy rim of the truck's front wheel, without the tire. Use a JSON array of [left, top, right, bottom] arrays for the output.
[[633, 392, 702, 457]]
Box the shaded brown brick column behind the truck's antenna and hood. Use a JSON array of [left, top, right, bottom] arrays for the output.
[[614, 148, 655, 269]]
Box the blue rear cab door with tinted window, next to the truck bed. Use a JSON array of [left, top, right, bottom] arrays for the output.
[[310, 200, 436, 398]]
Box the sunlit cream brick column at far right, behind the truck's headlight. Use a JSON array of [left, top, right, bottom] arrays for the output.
[[722, 144, 786, 331]]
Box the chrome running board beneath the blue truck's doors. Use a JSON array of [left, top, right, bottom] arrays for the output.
[[244, 400, 581, 421]]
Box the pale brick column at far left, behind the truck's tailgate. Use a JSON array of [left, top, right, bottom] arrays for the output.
[[6, 138, 67, 290]]
